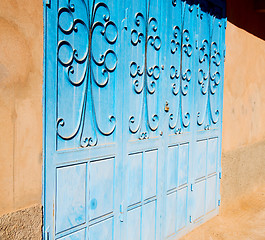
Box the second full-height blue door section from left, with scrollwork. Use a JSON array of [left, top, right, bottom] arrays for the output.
[[122, 0, 164, 240]]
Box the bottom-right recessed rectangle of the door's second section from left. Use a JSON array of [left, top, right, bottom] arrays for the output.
[[141, 201, 156, 240]]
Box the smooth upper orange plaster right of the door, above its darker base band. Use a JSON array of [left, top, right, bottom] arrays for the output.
[[222, 21, 265, 152]]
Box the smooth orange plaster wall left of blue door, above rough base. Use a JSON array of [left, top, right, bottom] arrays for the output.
[[0, 0, 43, 216]]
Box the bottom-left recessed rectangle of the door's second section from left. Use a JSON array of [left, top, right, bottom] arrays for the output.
[[127, 207, 141, 240]]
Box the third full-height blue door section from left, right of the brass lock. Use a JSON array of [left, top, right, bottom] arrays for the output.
[[162, 1, 196, 239]]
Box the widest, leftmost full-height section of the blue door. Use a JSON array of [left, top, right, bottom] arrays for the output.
[[44, 0, 124, 240]]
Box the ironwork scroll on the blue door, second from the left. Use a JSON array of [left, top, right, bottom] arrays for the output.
[[129, 5, 161, 139]]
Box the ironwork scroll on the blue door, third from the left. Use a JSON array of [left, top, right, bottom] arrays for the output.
[[169, 0, 193, 134]]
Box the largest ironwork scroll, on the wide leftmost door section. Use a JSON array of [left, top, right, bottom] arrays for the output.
[[57, 0, 118, 147]]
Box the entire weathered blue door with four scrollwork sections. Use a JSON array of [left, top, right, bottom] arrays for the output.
[[43, 0, 226, 240]]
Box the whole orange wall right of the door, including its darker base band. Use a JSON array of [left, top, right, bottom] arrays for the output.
[[221, 20, 265, 209]]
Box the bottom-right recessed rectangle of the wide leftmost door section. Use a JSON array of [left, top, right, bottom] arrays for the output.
[[88, 217, 113, 240]]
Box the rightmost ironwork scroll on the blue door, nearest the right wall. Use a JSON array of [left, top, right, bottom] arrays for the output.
[[197, 15, 222, 130]]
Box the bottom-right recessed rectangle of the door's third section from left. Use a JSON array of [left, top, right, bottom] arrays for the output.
[[177, 187, 188, 231]]
